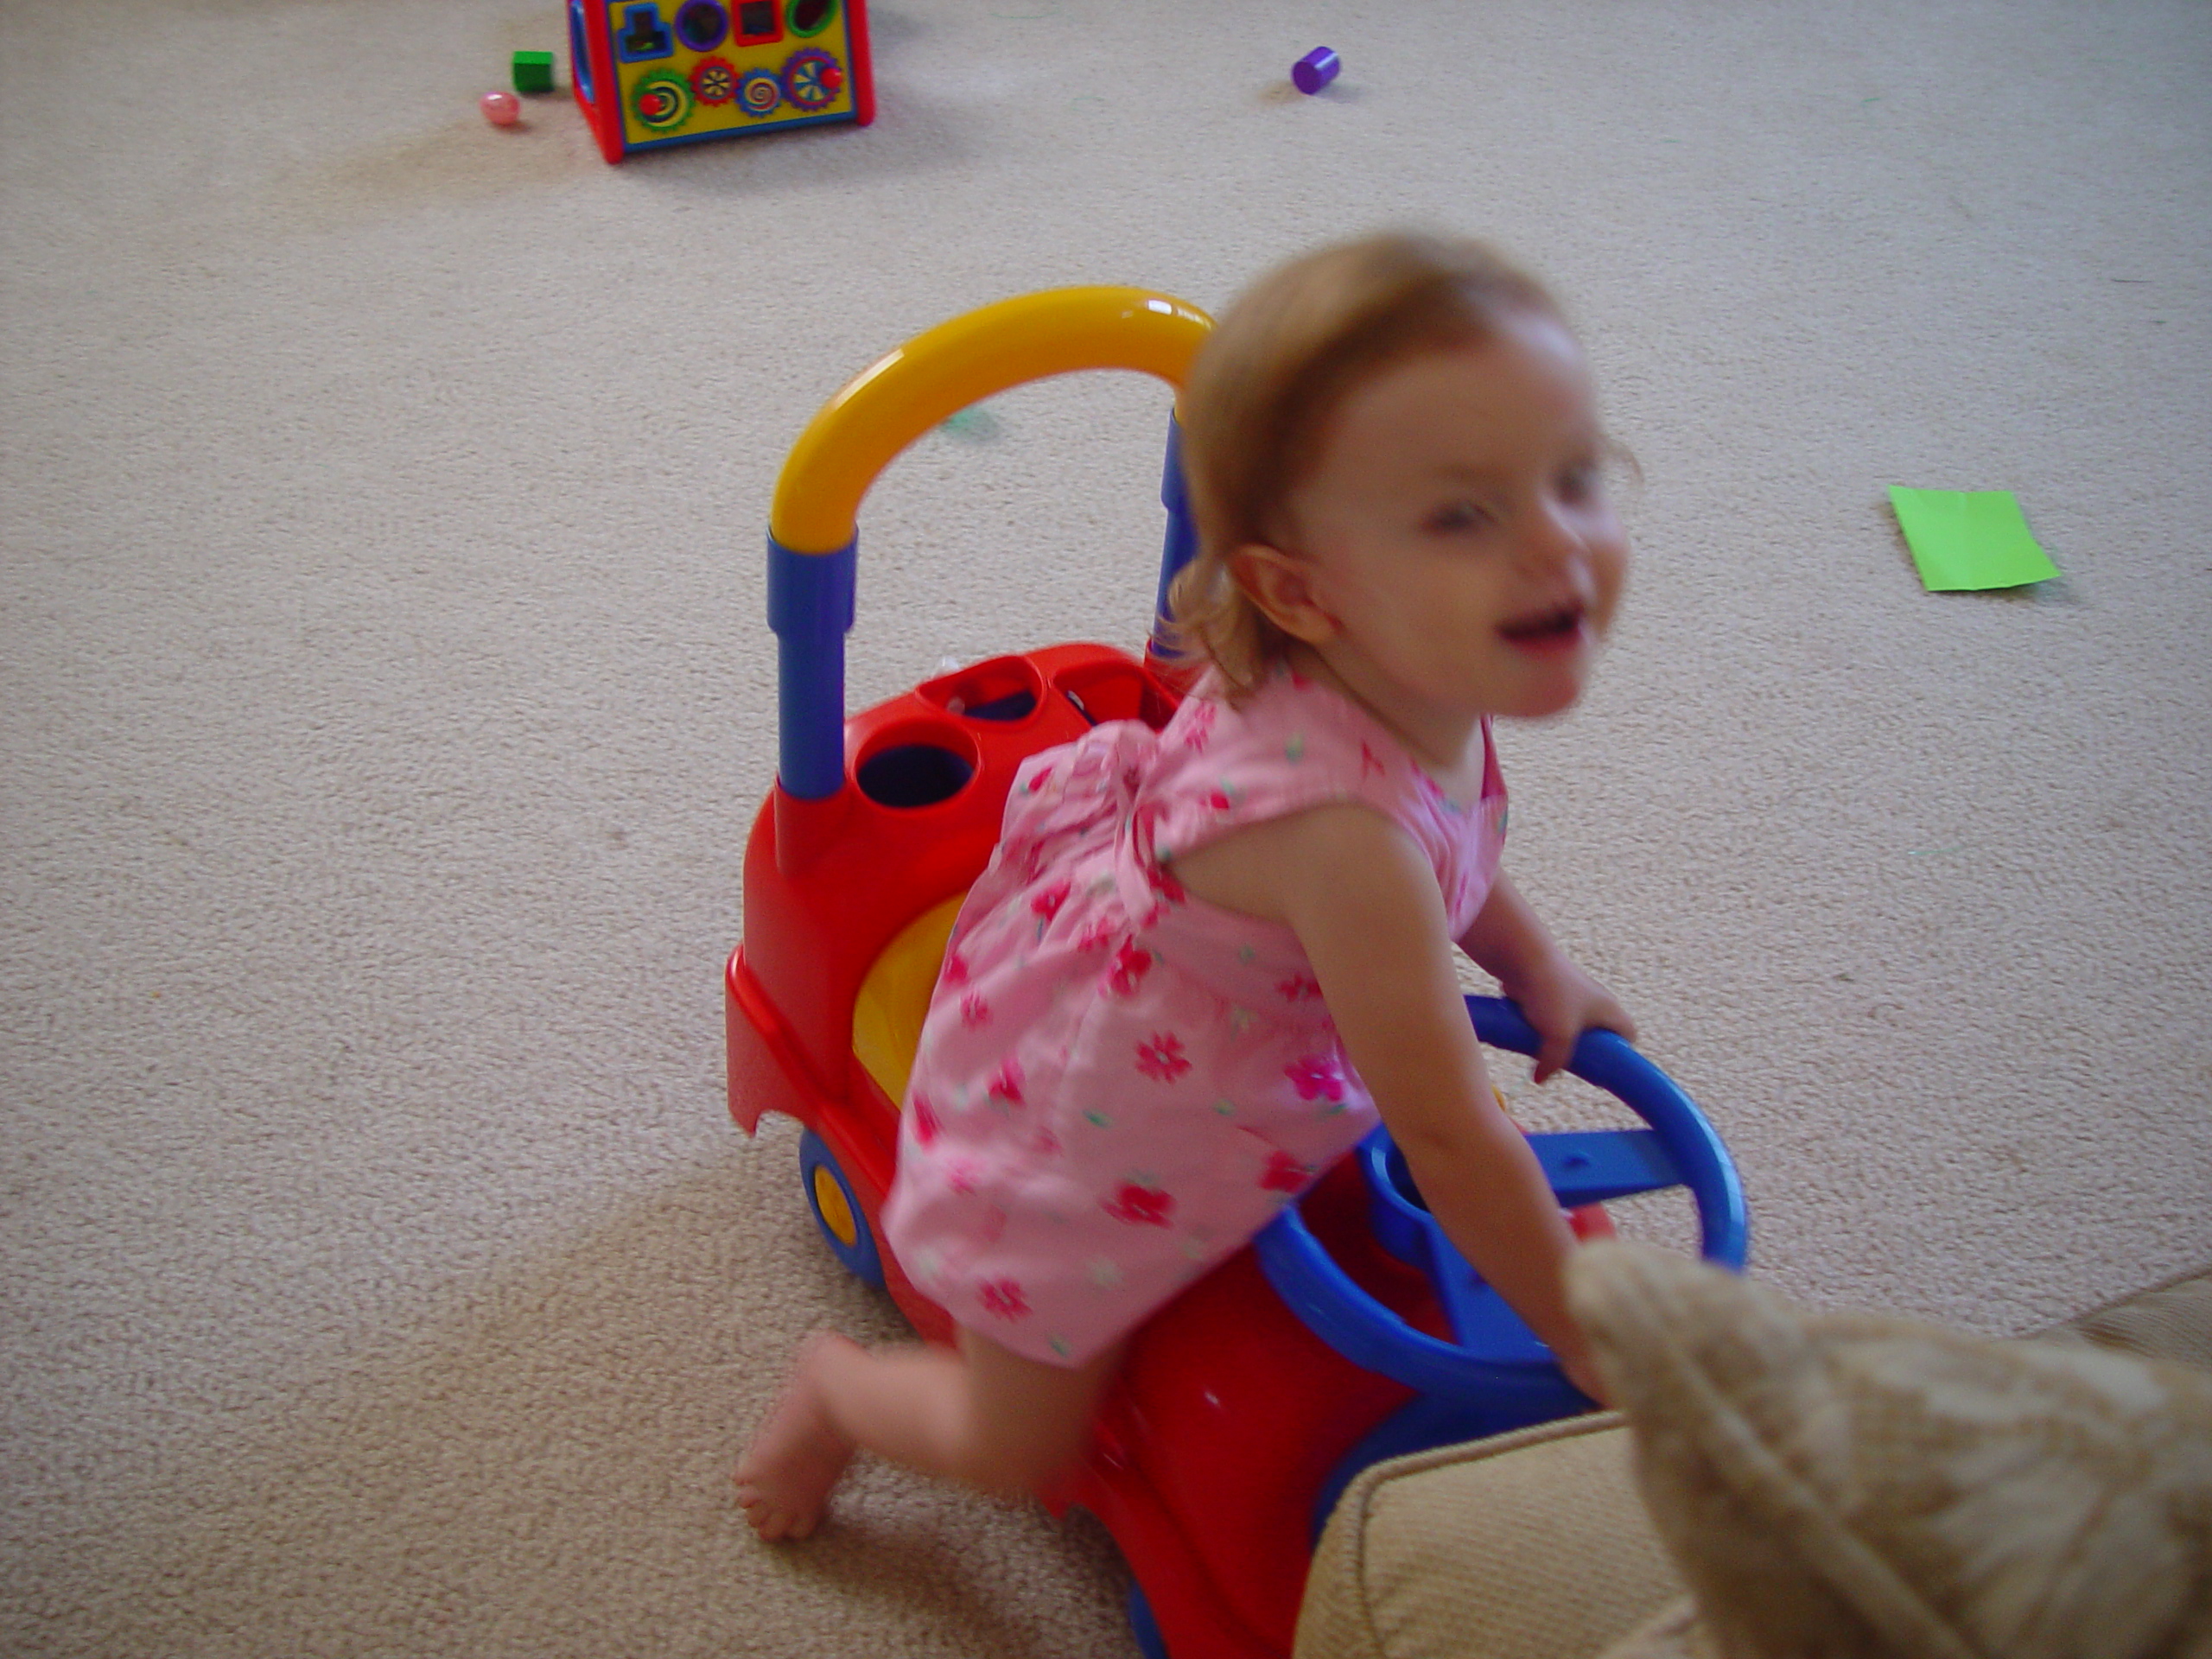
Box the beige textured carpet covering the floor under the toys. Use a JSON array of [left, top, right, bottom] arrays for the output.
[[0, 0, 2212, 1659]]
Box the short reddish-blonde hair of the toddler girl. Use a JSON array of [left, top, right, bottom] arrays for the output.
[[1168, 232, 1566, 695]]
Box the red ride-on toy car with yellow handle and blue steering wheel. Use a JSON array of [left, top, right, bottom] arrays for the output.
[[726, 288, 1745, 1659]]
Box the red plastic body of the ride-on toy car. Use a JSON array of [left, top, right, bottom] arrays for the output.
[[728, 646, 1557, 1659]]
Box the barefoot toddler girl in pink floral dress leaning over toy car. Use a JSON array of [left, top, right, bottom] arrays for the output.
[[736, 234, 1635, 1540]]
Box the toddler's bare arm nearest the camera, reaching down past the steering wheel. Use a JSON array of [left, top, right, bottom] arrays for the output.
[[1217, 805, 1597, 1395]]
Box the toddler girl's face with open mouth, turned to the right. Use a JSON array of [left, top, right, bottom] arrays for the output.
[[1287, 312, 1628, 716]]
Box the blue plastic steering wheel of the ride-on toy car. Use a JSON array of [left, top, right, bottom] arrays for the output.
[[1255, 995, 1747, 1422]]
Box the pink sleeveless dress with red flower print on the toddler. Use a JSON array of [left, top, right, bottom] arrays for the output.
[[882, 671, 1506, 1365]]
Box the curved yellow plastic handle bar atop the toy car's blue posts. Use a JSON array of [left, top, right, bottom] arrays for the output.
[[767, 288, 1212, 553]]
